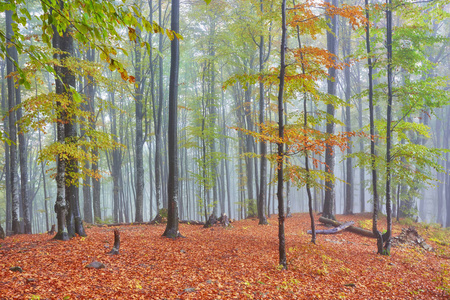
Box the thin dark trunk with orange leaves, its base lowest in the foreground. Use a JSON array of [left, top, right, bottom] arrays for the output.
[[277, 0, 287, 269]]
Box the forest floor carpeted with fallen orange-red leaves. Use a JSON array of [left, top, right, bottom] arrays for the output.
[[0, 214, 450, 299]]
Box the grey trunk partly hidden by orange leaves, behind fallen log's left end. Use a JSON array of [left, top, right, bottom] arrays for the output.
[[323, 0, 338, 219]]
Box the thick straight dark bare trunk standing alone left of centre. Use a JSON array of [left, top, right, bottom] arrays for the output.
[[163, 0, 181, 238]]
